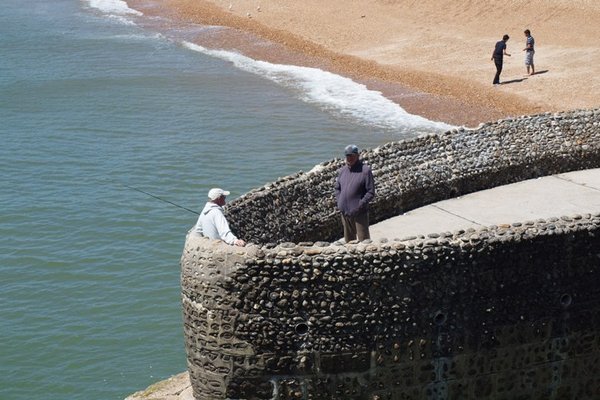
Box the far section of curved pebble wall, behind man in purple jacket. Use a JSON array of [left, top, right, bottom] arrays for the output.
[[228, 109, 600, 243]]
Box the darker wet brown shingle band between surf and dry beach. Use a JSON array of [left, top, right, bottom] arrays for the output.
[[128, 0, 506, 128]]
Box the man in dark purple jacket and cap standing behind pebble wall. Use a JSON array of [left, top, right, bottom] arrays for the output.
[[335, 144, 375, 242]]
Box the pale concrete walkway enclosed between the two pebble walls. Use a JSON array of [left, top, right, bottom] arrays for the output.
[[370, 168, 600, 240]]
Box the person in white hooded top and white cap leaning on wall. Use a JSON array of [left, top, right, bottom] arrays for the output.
[[193, 188, 246, 246]]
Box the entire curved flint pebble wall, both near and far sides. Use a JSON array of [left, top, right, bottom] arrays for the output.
[[181, 110, 600, 400]]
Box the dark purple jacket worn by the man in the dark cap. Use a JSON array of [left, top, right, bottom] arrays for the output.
[[335, 160, 375, 217]]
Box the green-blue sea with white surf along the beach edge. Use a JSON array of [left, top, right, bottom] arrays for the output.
[[0, 0, 446, 400]]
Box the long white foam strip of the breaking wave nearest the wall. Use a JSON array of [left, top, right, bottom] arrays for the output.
[[184, 42, 452, 131]]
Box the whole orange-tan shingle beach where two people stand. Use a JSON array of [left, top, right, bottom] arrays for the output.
[[128, 0, 600, 127]]
